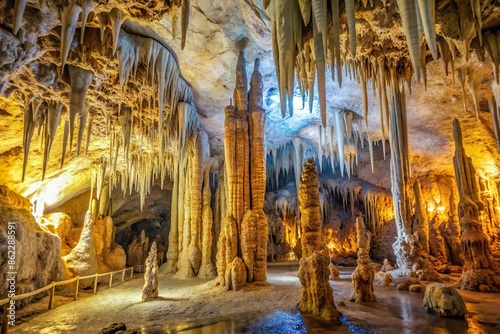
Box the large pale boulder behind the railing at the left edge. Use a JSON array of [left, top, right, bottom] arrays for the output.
[[0, 186, 65, 303]]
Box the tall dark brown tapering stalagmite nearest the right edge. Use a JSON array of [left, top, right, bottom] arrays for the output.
[[453, 119, 496, 291]]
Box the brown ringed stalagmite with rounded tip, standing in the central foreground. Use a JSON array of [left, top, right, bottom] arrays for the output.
[[297, 158, 341, 321]]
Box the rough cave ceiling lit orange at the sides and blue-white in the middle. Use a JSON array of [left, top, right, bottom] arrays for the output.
[[0, 0, 500, 209]]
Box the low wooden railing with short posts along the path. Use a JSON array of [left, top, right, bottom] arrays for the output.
[[0, 266, 136, 334]]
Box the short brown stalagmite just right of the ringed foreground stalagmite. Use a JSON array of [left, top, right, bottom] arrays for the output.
[[348, 217, 377, 303]]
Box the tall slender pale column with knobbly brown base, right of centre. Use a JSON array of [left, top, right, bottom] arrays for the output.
[[389, 79, 440, 281]]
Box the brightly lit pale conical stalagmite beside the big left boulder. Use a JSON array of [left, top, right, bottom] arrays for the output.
[[63, 211, 98, 287]]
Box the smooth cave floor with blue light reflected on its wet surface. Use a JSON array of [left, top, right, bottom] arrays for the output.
[[9, 263, 500, 334]]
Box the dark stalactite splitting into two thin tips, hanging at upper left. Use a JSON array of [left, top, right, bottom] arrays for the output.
[[68, 65, 94, 156]]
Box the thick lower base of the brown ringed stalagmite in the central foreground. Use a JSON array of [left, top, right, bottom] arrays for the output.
[[297, 251, 341, 321]]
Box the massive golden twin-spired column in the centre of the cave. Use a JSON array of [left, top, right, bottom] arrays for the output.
[[217, 52, 268, 290]]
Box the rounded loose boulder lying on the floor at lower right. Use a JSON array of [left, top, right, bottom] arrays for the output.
[[424, 283, 467, 317]]
